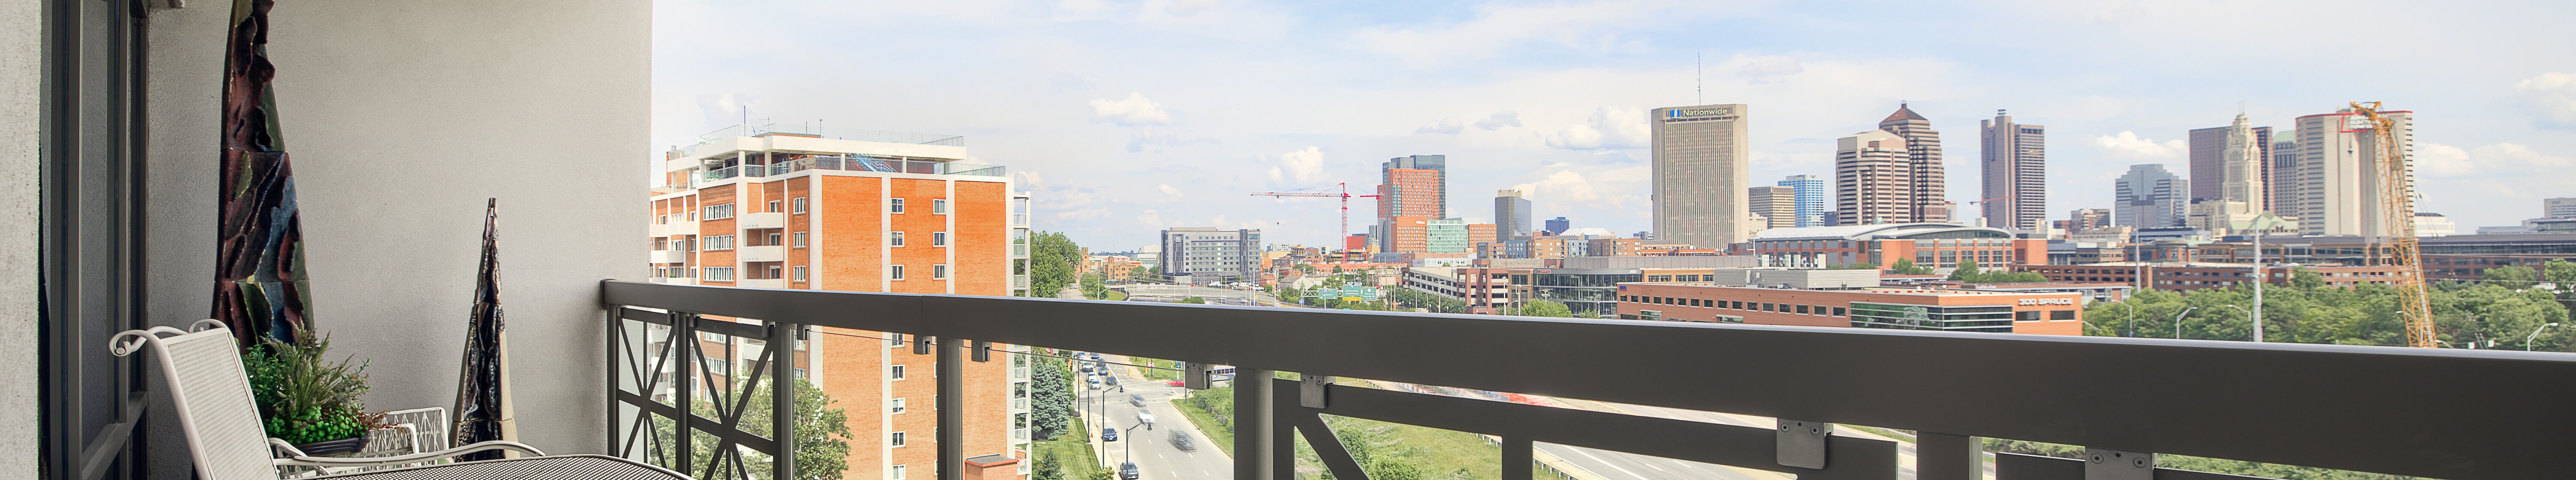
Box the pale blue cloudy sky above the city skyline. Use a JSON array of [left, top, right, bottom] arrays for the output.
[[654, 0, 2576, 250]]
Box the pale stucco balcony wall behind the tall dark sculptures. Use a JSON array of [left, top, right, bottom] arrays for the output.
[[136, 0, 652, 477]]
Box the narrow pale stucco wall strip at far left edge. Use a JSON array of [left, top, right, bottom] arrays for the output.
[[0, 0, 44, 477]]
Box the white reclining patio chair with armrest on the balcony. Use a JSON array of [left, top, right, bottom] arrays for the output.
[[108, 320, 688, 480]]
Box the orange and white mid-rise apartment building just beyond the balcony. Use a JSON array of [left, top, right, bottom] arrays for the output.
[[647, 124, 1025, 475]]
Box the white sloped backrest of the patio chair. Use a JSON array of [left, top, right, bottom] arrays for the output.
[[111, 328, 278, 480]]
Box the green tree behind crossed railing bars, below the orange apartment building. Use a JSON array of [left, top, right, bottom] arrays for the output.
[[657, 379, 850, 480]]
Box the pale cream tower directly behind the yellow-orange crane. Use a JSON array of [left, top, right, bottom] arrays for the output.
[[2285, 108, 2414, 235]]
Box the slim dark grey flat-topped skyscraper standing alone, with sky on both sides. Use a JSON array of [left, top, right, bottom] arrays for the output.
[[1976, 111, 2048, 230]]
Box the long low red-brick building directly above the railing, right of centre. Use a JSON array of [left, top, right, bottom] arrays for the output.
[[1618, 284, 2084, 336]]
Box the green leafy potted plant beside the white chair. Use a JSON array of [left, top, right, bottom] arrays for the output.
[[245, 328, 384, 454]]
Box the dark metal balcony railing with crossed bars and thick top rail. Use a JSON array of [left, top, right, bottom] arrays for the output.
[[603, 281, 2576, 480]]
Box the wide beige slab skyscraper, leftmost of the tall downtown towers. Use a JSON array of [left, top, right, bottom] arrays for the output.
[[1646, 103, 1752, 248]]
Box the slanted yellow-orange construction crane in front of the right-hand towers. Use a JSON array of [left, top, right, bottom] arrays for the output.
[[2344, 101, 2434, 348]]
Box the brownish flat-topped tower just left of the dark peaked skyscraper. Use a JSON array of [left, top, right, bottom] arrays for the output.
[[1834, 129, 1914, 225]]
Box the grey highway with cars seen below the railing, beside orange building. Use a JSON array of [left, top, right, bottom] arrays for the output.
[[1074, 356, 1234, 480]]
